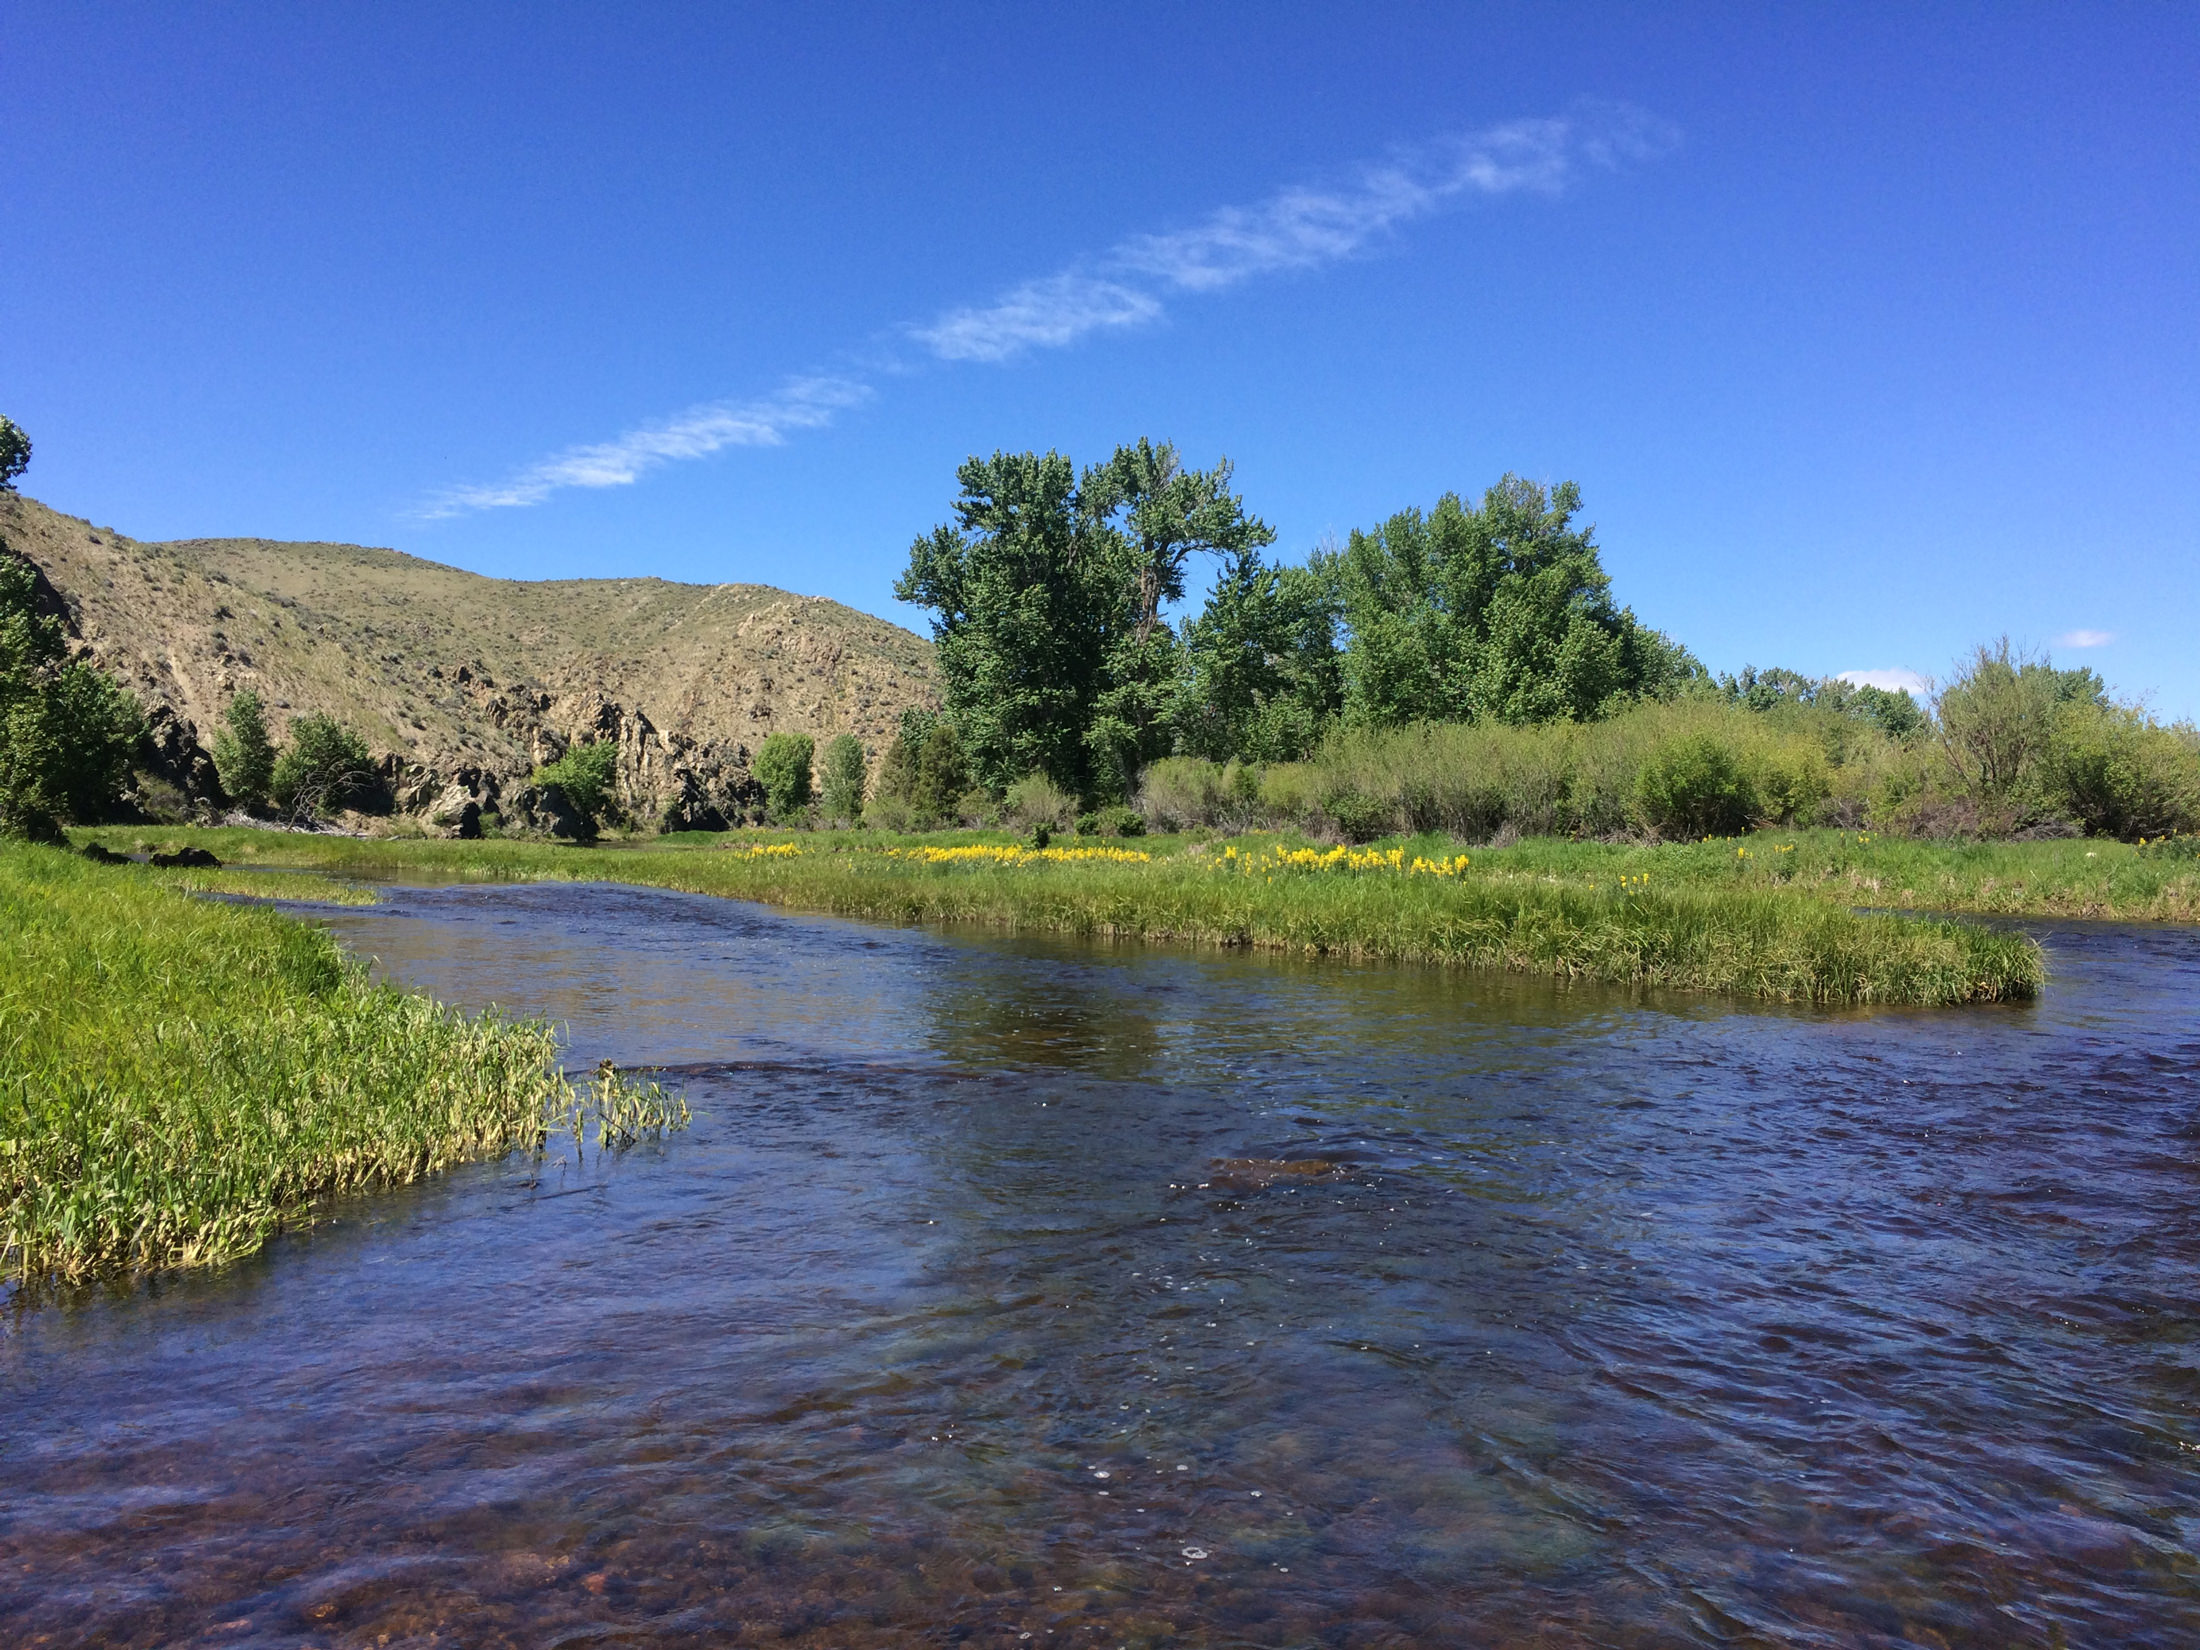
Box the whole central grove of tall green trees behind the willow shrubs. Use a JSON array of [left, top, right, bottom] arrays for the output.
[[882, 440, 1709, 801]]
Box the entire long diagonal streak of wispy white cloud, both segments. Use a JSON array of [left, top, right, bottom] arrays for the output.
[[418, 106, 1676, 519]]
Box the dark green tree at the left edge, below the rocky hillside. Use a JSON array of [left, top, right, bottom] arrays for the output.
[[0, 556, 145, 840]]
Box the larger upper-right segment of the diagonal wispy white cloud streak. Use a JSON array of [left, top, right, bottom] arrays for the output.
[[909, 108, 1676, 361]]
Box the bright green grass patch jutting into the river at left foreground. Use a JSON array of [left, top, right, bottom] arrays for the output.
[[0, 845, 684, 1280]]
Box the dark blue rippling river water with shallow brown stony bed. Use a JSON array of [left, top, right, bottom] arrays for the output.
[[0, 887, 2200, 1648]]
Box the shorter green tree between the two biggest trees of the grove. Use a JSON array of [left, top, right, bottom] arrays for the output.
[[1170, 548, 1344, 761]]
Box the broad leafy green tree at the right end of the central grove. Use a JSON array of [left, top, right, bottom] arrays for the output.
[[1320, 475, 1705, 726]]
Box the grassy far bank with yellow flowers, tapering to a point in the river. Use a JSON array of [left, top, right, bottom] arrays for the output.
[[73, 829, 2042, 1005]]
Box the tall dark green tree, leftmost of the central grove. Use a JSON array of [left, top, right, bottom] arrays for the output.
[[893, 451, 1137, 794]]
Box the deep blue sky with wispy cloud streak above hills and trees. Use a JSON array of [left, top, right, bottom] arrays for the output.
[[0, 4, 2200, 717]]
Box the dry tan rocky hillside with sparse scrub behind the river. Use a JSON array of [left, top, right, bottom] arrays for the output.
[[0, 497, 937, 832]]
